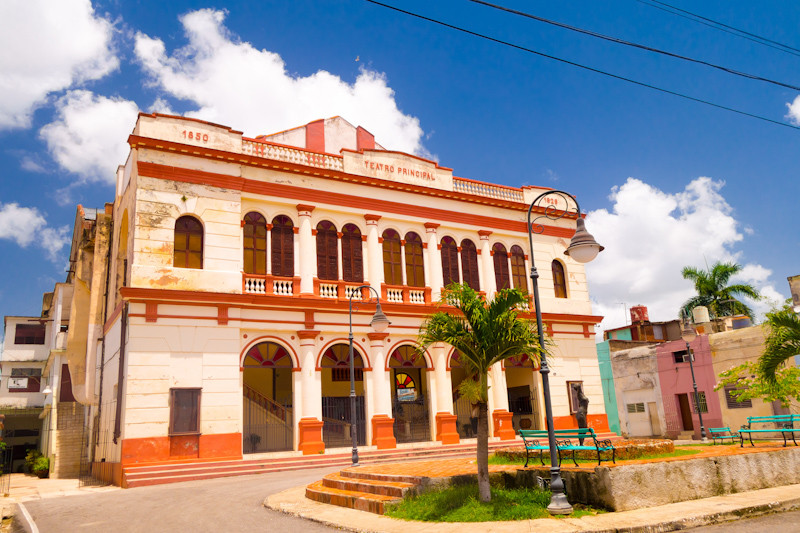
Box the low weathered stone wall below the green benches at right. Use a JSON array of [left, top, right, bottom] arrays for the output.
[[508, 447, 800, 511]]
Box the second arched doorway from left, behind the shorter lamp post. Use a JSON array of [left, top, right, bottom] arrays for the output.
[[319, 344, 367, 448]]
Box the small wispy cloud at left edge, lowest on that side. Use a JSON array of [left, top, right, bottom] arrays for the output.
[[0, 203, 69, 262]]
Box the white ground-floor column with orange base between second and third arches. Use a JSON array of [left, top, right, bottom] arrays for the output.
[[367, 331, 397, 450]]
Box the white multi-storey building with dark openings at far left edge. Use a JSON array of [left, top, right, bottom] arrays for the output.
[[0, 316, 50, 472]]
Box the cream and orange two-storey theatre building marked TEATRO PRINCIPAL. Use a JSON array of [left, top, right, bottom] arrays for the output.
[[89, 114, 608, 477]]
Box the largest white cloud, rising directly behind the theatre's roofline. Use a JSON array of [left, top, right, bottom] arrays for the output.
[[135, 9, 425, 155]]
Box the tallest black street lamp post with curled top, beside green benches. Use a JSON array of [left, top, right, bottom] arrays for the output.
[[528, 190, 603, 514]]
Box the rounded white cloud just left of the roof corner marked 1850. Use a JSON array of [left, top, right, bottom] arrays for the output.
[[40, 90, 139, 184]]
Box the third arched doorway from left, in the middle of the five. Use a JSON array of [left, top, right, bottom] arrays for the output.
[[388, 345, 431, 443]]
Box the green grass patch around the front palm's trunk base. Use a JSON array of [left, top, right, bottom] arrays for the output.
[[385, 482, 603, 522]]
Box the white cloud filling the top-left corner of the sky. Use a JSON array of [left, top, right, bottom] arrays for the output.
[[0, 0, 119, 130]]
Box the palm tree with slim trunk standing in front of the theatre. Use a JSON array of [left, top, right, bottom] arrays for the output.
[[419, 284, 540, 502]]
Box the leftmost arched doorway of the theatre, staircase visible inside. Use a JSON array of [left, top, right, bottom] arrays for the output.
[[242, 342, 294, 453]]
